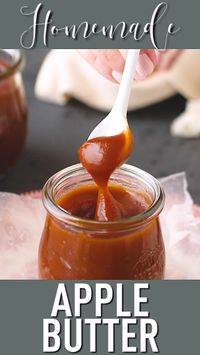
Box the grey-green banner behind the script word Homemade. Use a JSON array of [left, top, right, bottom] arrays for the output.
[[0, 0, 200, 48]]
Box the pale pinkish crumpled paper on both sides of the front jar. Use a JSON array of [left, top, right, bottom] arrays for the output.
[[0, 173, 200, 279]]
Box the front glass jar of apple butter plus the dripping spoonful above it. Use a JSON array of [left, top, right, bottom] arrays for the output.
[[39, 87, 165, 280]]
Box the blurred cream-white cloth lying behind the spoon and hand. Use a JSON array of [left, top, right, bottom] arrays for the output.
[[35, 49, 200, 137]]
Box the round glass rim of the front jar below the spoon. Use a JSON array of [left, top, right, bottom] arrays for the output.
[[43, 164, 165, 231]]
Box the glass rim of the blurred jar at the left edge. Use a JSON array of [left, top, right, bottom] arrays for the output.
[[0, 49, 25, 80]]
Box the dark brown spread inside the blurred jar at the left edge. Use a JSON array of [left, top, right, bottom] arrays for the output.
[[0, 58, 27, 175]]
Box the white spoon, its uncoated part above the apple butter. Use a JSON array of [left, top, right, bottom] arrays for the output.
[[88, 49, 140, 140]]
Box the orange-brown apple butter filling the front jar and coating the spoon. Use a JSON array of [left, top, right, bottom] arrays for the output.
[[39, 110, 165, 280]]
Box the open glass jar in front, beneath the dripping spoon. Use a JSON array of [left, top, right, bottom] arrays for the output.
[[39, 164, 165, 280]]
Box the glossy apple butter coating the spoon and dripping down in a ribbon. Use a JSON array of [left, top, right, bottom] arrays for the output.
[[79, 128, 133, 221]]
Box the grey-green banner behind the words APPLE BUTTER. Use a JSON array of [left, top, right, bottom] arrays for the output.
[[0, 280, 200, 355]]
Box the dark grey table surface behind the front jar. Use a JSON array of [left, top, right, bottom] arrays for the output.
[[0, 49, 200, 203]]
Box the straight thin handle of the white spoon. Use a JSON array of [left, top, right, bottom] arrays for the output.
[[113, 49, 140, 117]]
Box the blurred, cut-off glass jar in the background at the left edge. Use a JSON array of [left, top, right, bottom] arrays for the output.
[[0, 49, 27, 175]]
